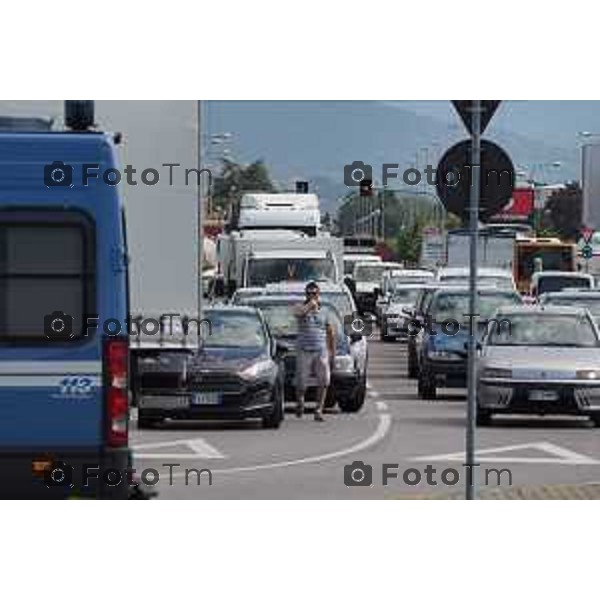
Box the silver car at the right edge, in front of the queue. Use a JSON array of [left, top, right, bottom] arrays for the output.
[[477, 306, 600, 426]]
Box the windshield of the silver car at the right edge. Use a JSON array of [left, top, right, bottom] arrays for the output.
[[488, 314, 599, 348]]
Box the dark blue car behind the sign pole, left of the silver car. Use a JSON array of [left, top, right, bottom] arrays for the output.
[[415, 288, 523, 400]]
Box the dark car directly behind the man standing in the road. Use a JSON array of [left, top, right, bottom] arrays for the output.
[[240, 294, 367, 412]]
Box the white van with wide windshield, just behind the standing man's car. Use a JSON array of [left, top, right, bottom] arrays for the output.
[[217, 229, 343, 295]]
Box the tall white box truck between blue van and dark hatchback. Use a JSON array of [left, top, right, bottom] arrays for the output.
[[96, 101, 202, 412]]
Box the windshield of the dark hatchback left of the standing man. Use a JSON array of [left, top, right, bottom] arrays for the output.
[[203, 310, 267, 348]]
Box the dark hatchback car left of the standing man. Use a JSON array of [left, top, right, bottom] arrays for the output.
[[138, 306, 285, 429]]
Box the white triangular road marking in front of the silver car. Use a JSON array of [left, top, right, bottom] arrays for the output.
[[413, 442, 600, 465]]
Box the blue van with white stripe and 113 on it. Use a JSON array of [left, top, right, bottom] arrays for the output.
[[0, 101, 130, 498]]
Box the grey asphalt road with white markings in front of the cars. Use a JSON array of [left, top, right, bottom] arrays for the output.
[[132, 338, 600, 499]]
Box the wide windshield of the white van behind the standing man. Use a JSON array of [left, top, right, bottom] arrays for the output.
[[246, 258, 335, 287]]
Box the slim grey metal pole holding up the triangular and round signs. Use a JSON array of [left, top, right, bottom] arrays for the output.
[[465, 100, 481, 500]]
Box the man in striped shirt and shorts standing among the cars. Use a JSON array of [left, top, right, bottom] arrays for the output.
[[296, 281, 335, 421]]
